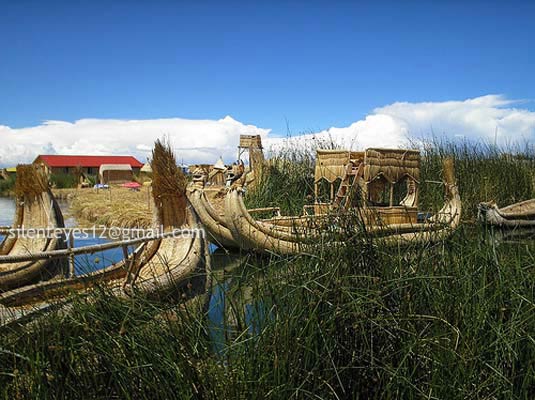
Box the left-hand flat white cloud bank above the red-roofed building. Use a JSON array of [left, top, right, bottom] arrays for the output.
[[0, 116, 270, 166]]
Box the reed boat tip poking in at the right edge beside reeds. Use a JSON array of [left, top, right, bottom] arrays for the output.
[[478, 199, 535, 228]]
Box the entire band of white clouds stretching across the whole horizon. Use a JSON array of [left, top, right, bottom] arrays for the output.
[[0, 95, 535, 166]]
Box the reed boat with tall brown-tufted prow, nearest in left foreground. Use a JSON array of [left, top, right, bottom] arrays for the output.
[[0, 141, 210, 314]]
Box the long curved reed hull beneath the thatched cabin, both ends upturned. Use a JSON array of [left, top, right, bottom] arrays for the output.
[[225, 160, 461, 254]]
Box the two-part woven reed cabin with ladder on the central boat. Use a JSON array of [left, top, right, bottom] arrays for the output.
[[308, 148, 420, 224]]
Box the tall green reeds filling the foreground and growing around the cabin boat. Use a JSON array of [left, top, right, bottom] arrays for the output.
[[0, 144, 535, 399]]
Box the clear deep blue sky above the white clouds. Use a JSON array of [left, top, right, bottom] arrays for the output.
[[0, 1, 535, 134]]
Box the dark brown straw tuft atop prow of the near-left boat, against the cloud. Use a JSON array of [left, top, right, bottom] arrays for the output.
[[151, 140, 187, 229]]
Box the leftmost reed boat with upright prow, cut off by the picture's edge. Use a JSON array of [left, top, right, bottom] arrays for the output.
[[0, 165, 66, 291]]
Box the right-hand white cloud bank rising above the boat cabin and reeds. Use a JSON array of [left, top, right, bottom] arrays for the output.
[[269, 95, 535, 154]]
